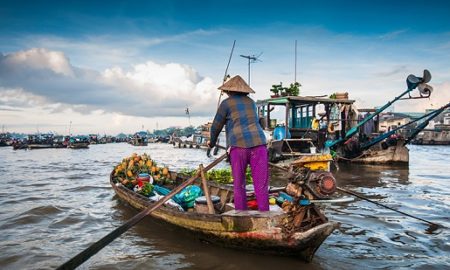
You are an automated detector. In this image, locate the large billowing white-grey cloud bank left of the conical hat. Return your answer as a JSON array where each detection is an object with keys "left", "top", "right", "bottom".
[{"left": 0, "top": 49, "right": 217, "bottom": 117}]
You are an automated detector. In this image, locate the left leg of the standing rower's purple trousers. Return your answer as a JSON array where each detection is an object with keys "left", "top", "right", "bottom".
[{"left": 230, "top": 146, "right": 250, "bottom": 210}]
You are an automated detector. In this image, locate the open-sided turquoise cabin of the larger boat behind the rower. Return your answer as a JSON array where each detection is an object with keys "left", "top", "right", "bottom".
[{"left": 256, "top": 95, "right": 357, "bottom": 161}]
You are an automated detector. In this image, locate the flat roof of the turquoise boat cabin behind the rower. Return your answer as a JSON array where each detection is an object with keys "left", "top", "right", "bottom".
[{"left": 256, "top": 96, "right": 355, "bottom": 105}]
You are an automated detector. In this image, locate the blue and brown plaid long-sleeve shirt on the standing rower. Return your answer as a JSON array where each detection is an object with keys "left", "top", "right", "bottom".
[{"left": 210, "top": 95, "right": 266, "bottom": 148}]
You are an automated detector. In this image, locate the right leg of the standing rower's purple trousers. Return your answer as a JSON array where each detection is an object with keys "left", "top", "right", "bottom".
[{"left": 249, "top": 145, "right": 269, "bottom": 211}]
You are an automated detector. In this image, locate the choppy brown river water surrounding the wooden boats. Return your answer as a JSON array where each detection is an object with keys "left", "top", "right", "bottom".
[{"left": 0, "top": 143, "right": 450, "bottom": 270}]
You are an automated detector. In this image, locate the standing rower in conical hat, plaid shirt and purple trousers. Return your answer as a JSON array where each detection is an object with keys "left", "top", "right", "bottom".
[{"left": 208, "top": 75, "right": 269, "bottom": 211}]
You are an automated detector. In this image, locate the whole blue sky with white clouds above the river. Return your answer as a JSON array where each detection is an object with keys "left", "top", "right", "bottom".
[{"left": 0, "top": 0, "right": 450, "bottom": 135}]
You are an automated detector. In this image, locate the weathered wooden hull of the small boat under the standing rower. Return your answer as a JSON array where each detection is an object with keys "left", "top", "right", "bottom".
[{"left": 110, "top": 171, "right": 338, "bottom": 262}]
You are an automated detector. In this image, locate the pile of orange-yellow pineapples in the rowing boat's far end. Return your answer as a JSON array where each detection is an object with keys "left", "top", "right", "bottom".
[{"left": 114, "top": 153, "right": 172, "bottom": 189}]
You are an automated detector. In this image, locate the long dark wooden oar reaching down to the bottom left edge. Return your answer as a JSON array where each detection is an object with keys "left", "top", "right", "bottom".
[{"left": 57, "top": 153, "right": 227, "bottom": 269}]
